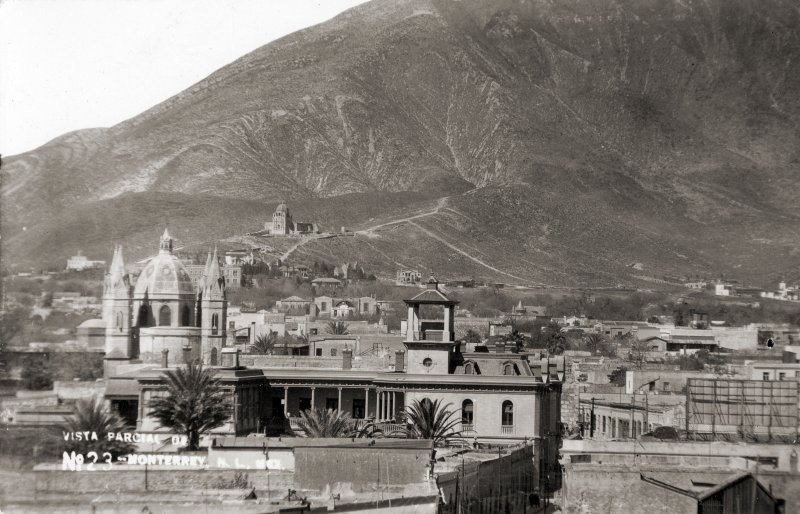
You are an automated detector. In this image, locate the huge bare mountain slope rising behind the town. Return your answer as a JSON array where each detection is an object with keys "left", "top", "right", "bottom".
[{"left": 2, "top": 0, "right": 800, "bottom": 285}]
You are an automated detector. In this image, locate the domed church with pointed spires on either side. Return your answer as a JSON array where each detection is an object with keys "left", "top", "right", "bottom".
[{"left": 103, "top": 230, "right": 228, "bottom": 376}]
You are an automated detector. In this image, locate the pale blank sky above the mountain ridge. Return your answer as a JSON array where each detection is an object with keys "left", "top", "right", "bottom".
[{"left": 0, "top": 0, "right": 364, "bottom": 156}]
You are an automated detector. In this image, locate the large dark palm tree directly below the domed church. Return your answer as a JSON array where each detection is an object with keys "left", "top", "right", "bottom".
[{"left": 151, "top": 363, "right": 230, "bottom": 451}]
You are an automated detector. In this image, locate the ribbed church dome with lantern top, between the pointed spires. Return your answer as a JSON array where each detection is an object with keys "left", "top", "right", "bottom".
[{"left": 133, "top": 231, "right": 195, "bottom": 298}]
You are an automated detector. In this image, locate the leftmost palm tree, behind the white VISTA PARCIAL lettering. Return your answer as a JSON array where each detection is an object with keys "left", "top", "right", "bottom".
[{"left": 59, "top": 398, "right": 135, "bottom": 460}]
